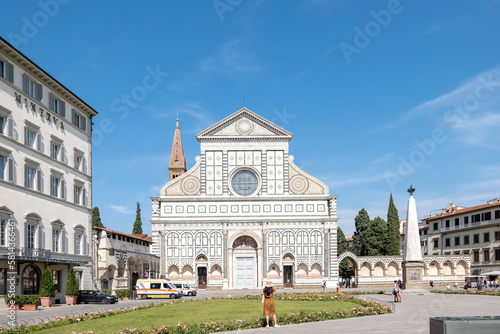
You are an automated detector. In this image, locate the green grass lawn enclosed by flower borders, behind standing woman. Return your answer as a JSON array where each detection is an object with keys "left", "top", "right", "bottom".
[{"left": 37, "top": 299, "right": 360, "bottom": 334}]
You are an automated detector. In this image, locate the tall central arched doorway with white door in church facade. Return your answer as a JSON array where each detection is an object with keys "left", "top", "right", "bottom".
[{"left": 232, "top": 235, "right": 257, "bottom": 289}]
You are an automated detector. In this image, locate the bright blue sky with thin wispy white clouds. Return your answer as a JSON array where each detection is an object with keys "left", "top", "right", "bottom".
[{"left": 0, "top": 0, "right": 500, "bottom": 237}]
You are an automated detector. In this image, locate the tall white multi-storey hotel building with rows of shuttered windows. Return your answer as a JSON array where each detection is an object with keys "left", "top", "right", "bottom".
[{"left": 0, "top": 38, "right": 97, "bottom": 302}]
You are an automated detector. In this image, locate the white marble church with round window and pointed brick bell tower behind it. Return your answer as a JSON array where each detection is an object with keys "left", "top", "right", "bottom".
[{"left": 151, "top": 108, "right": 338, "bottom": 289}]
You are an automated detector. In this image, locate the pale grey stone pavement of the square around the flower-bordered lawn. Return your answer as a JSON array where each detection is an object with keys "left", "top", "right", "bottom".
[{"left": 0, "top": 288, "right": 500, "bottom": 334}]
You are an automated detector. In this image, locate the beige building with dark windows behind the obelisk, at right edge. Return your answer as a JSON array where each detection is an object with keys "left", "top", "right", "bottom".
[{"left": 422, "top": 199, "right": 500, "bottom": 275}]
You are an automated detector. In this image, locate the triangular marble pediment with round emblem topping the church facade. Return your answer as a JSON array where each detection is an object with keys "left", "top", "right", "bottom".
[{"left": 196, "top": 108, "right": 293, "bottom": 141}]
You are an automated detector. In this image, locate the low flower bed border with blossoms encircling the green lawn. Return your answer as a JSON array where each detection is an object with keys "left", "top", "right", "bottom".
[{"left": 0, "top": 293, "right": 391, "bottom": 334}]
